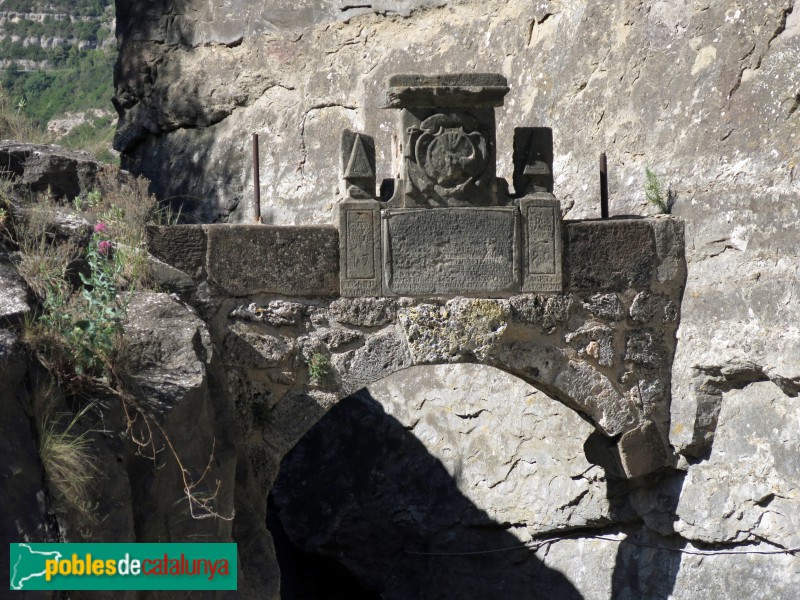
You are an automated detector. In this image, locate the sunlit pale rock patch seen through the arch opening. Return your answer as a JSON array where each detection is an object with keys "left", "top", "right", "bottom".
[{"left": 368, "top": 365, "right": 609, "bottom": 540}]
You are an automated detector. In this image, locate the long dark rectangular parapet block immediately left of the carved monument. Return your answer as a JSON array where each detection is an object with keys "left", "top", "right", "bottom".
[{"left": 207, "top": 225, "right": 339, "bottom": 296}]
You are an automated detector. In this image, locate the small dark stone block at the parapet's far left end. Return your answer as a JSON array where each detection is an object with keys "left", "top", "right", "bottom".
[{"left": 147, "top": 225, "right": 207, "bottom": 279}]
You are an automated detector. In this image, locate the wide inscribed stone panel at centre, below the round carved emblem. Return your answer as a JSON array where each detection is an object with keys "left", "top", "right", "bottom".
[{"left": 382, "top": 208, "right": 519, "bottom": 296}]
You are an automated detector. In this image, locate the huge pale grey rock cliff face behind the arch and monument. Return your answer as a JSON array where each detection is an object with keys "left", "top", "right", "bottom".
[{"left": 116, "top": 0, "right": 800, "bottom": 598}]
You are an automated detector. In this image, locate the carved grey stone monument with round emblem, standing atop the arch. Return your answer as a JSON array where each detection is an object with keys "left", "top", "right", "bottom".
[{"left": 339, "top": 73, "right": 562, "bottom": 296}]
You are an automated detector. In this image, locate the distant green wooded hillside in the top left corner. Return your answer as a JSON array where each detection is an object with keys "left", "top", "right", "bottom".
[{"left": 0, "top": 0, "right": 118, "bottom": 162}]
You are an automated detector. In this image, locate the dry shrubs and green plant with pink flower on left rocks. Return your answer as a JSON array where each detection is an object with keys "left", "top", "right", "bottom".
[{"left": 14, "top": 167, "right": 160, "bottom": 386}]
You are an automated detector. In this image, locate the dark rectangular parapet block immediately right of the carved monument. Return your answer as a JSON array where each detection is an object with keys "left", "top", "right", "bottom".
[{"left": 564, "top": 219, "right": 656, "bottom": 292}]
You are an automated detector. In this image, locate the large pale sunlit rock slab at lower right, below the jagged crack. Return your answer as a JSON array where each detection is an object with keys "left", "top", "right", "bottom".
[{"left": 675, "top": 382, "right": 800, "bottom": 548}]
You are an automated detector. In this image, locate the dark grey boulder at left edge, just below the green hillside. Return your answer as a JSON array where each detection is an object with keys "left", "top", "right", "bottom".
[{"left": 0, "top": 140, "right": 101, "bottom": 200}]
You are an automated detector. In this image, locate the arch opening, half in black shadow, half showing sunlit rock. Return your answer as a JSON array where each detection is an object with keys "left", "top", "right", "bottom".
[{"left": 270, "top": 364, "right": 596, "bottom": 600}]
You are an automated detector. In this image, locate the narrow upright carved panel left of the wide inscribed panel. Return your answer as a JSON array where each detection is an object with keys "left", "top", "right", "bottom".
[{"left": 339, "top": 200, "right": 381, "bottom": 297}]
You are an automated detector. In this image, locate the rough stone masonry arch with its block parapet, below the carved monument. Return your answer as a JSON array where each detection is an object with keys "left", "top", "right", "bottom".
[{"left": 149, "top": 217, "right": 686, "bottom": 479}]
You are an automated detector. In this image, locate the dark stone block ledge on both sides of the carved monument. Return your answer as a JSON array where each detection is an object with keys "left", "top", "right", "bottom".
[{"left": 147, "top": 217, "right": 685, "bottom": 297}]
